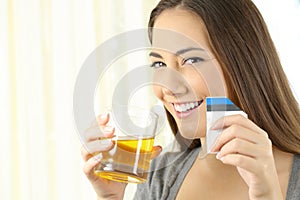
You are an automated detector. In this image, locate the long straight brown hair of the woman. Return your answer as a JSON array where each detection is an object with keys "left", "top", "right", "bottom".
[{"left": 148, "top": 0, "right": 300, "bottom": 154}]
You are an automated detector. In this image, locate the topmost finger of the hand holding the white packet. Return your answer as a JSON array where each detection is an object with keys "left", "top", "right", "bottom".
[{"left": 211, "top": 115, "right": 268, "bottom": 136}]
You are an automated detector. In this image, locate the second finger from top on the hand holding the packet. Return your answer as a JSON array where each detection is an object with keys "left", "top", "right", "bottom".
[{"left": 212, "top": 124, "right": 266, "bottom": 152}]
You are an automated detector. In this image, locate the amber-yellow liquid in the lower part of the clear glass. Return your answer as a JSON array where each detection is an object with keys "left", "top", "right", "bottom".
[{"left": 95, "top": 136, "right": 154, "bottom": 183}]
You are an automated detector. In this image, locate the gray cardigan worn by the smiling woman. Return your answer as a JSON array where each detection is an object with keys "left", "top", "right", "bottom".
[{"left": 134, "top": 148, "right": 300, "bottom": 200}]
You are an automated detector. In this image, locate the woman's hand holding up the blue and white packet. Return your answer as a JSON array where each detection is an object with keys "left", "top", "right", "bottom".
[{"left": 211, "top": 115, "right": 283, "bottom": 200}]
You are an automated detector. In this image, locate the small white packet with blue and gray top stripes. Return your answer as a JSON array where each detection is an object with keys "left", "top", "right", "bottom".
[{"left": 206, "top": 97, "right": 248, "bottom": 154}]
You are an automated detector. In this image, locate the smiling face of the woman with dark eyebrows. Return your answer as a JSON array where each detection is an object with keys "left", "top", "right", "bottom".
[{"left": 150, "top": 9, "right": 226, "bottom": 139}]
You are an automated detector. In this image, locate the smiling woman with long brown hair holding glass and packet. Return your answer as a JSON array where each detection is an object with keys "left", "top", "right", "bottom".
[{"left": 82, "top": 0, "right": 300, "bottom": 200}]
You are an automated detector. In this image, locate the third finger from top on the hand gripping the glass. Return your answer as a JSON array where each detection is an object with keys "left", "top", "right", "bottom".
[{"left": 84, "top": 140, "right": 114, "bottom": 154}]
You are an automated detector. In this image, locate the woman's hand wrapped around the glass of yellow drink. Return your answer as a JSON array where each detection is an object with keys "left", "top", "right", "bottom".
[{"left": 81, "top": 114, "right": 161, "bottom": 199}]
